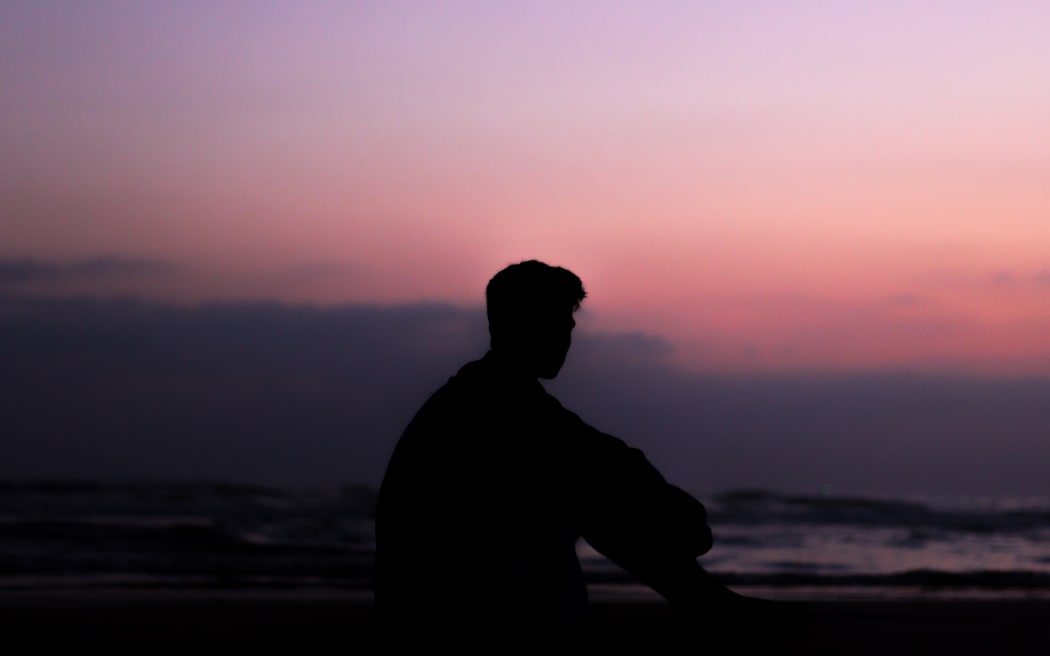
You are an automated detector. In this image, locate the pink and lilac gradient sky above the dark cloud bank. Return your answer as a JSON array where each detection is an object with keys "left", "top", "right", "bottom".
[{"left": 0, "top": 0, "right": 1050, "bottom": 376}]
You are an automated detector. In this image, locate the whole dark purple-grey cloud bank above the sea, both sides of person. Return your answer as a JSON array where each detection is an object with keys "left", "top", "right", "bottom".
[{"left": 0, "top": 297, "right": 1050, "bottom": 494}]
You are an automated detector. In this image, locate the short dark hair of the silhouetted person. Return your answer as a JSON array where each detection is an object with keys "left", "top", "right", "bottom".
[{"left": 485, "top": 259, "right": 587, "bottom": 334}]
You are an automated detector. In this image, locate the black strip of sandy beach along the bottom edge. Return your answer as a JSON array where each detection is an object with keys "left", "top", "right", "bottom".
[{"left": 0, "top": 600, "right": 1050, "bottom": 656}]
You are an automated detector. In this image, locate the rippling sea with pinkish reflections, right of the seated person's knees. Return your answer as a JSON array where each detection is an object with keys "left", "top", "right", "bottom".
[{"left": 581, "top": 490, "right": 1050, "bottom": 598}]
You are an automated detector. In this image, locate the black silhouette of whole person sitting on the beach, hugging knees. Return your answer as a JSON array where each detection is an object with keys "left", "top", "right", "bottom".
[{"left": 376, "top": 260, "right": 789, "bottom": 635}]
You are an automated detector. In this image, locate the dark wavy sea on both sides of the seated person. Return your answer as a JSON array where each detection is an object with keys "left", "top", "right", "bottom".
[{"left": 0, "top": 481, "right": 1050, "bottom": 607}]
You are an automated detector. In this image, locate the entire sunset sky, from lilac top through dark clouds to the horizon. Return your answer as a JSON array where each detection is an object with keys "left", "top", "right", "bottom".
[{"left": 0, "top": 0, "right": 1050, "bottom": 493}]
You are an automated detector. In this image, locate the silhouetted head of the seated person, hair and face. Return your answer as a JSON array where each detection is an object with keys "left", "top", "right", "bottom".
[{"left": 485, "top": 259, "right": 587, "bottom": 378}]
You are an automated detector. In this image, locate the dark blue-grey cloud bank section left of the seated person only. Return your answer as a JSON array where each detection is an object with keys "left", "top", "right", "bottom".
[{"left": 0, "top": 297, "right": 483, "bottom": 482}]
